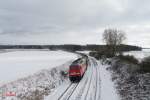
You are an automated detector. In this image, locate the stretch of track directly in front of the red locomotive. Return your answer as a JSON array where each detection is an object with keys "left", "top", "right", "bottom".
[{"left": 58, "top": 83, "right": 79, "bottom": 100}]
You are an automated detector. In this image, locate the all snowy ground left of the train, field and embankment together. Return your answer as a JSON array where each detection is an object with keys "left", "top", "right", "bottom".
[{"left": 0, "top": 50, "right": 77, "bottom": 100}]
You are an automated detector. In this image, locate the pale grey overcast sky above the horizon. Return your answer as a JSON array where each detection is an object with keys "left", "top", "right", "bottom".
[{"left": 0, "top": 0, "right": 150, "bottom": 47}]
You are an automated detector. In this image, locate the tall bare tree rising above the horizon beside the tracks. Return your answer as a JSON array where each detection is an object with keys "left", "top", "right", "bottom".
[{"left": 103, "top": 29, "right": 126, "bottom": 56}]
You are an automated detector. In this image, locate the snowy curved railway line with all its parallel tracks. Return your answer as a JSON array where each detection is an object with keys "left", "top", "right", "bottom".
[{"left": 46, "top": 57, "right": 100, "bottom": 100}]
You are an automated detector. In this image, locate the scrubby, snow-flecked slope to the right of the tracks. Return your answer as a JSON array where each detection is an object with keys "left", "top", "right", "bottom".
[{"left": 109, "top": 59, "right": 150, "bottom": 100}]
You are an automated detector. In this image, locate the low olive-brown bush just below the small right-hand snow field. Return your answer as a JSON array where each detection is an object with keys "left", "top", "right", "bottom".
[{"left": 118, "top": 55, "right": 139, "bottom": 64}]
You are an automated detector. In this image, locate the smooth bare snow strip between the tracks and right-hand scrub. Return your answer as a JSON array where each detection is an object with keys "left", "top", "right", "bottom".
[{"left": 99, "top": 61, "right": 120, "bottom": 100}]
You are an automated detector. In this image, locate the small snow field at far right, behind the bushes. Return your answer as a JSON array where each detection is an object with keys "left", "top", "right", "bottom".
[{"left": 124, "top": 49, "right": 150, "bottom": 61}]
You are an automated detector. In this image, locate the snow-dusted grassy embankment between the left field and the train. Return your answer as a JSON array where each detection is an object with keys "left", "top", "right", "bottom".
[{"left": 0, "top": 61, "right": 72, "bottom": 100}]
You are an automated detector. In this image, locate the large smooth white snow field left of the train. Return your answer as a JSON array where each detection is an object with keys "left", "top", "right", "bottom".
[{"left": 0, "top": 50, "right": 77, "bottom": 85}]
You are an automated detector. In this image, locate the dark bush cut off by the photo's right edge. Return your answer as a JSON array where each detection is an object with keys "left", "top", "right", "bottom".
[{"left": 140, "top": 56, "right": 150, "bottom": 72}]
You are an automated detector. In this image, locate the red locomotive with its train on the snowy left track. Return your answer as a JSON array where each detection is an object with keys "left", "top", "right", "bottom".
[{"left": 69, "top": 58, "right": 87, "bottom": 82}]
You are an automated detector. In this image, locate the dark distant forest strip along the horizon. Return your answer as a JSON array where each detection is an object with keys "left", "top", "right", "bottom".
[{"left": 0, "top": 44, "right": 142, "bottom": 51}]
